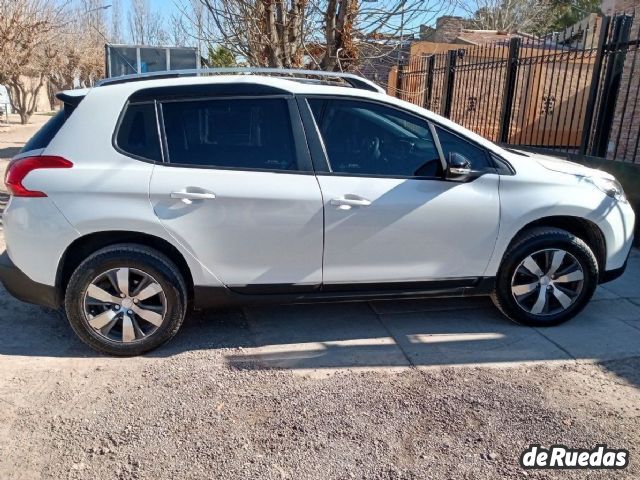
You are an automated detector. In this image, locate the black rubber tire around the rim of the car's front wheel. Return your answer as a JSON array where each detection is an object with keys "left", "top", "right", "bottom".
[{"left": 491, "top": 227, "right": 599, "bottom": 327}]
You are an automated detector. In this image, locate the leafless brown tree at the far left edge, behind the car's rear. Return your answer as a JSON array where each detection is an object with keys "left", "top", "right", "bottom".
[{"left": 0, "top": 0, "right": 63, "bottom": 124}]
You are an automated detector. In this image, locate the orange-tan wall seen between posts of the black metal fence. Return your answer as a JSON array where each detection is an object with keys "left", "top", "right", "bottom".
[{"left": 396, "top": 44, "right": 595, "bottom": 149}]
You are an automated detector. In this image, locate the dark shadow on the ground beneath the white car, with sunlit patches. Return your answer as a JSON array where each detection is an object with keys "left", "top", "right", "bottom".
[{"left": 0, "top": 282, "right": 640, "bottom": 385}]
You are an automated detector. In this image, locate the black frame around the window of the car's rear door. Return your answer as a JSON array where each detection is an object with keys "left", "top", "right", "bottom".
[{"left": 157, "top": 94, "right": 315, "bottom": 175}]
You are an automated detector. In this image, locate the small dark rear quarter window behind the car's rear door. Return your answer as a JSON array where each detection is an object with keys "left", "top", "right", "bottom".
[{"left": 116, "top": 103, "right": 162, "bottom": 161}]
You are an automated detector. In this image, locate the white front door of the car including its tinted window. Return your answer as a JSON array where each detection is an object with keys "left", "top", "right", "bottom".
[{"left": 308, "top": 97, "right": 500, "bottom": 289}]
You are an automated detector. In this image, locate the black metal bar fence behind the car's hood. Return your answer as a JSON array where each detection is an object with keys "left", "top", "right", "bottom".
[{"left": 395, "top": 14, "right": 640, "bottom": 163}]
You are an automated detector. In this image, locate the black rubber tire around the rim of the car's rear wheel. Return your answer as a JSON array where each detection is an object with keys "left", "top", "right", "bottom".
[{"left": 64, "top": 244, "right": 187, "bottom": 356}]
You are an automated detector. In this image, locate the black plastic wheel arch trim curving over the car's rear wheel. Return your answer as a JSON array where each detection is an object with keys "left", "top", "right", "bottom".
[{"left": 56, "top": 230, "right": 194, "bottom": 302}]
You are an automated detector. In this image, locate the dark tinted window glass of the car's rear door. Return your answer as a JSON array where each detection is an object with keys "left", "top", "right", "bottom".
[{"left": 162, "top": 98, "right": 297, "bottom": 170}]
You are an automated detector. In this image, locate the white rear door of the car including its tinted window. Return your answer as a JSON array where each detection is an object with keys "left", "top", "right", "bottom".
[{"left": 150, "top": 95, "right": 323, "bottom": 293}]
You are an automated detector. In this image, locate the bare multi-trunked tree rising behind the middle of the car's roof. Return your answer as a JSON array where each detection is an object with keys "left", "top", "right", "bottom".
[{"left": 182, "top": 0, "right": 448, "bottom": 70}]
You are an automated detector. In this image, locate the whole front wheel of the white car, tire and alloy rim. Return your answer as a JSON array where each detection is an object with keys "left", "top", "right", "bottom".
[{"left": 492, "top": 228, "right": 598, "bottom": 326}]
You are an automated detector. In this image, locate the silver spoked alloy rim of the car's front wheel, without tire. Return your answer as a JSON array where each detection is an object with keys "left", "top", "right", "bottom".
[{"left": 511, "top": 248, "right": 584, "bottom": 316}]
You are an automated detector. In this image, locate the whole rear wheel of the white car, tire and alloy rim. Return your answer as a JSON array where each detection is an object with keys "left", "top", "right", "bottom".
[{"left": 65, "top": 244, "right": 186, "bottom": 355}]
